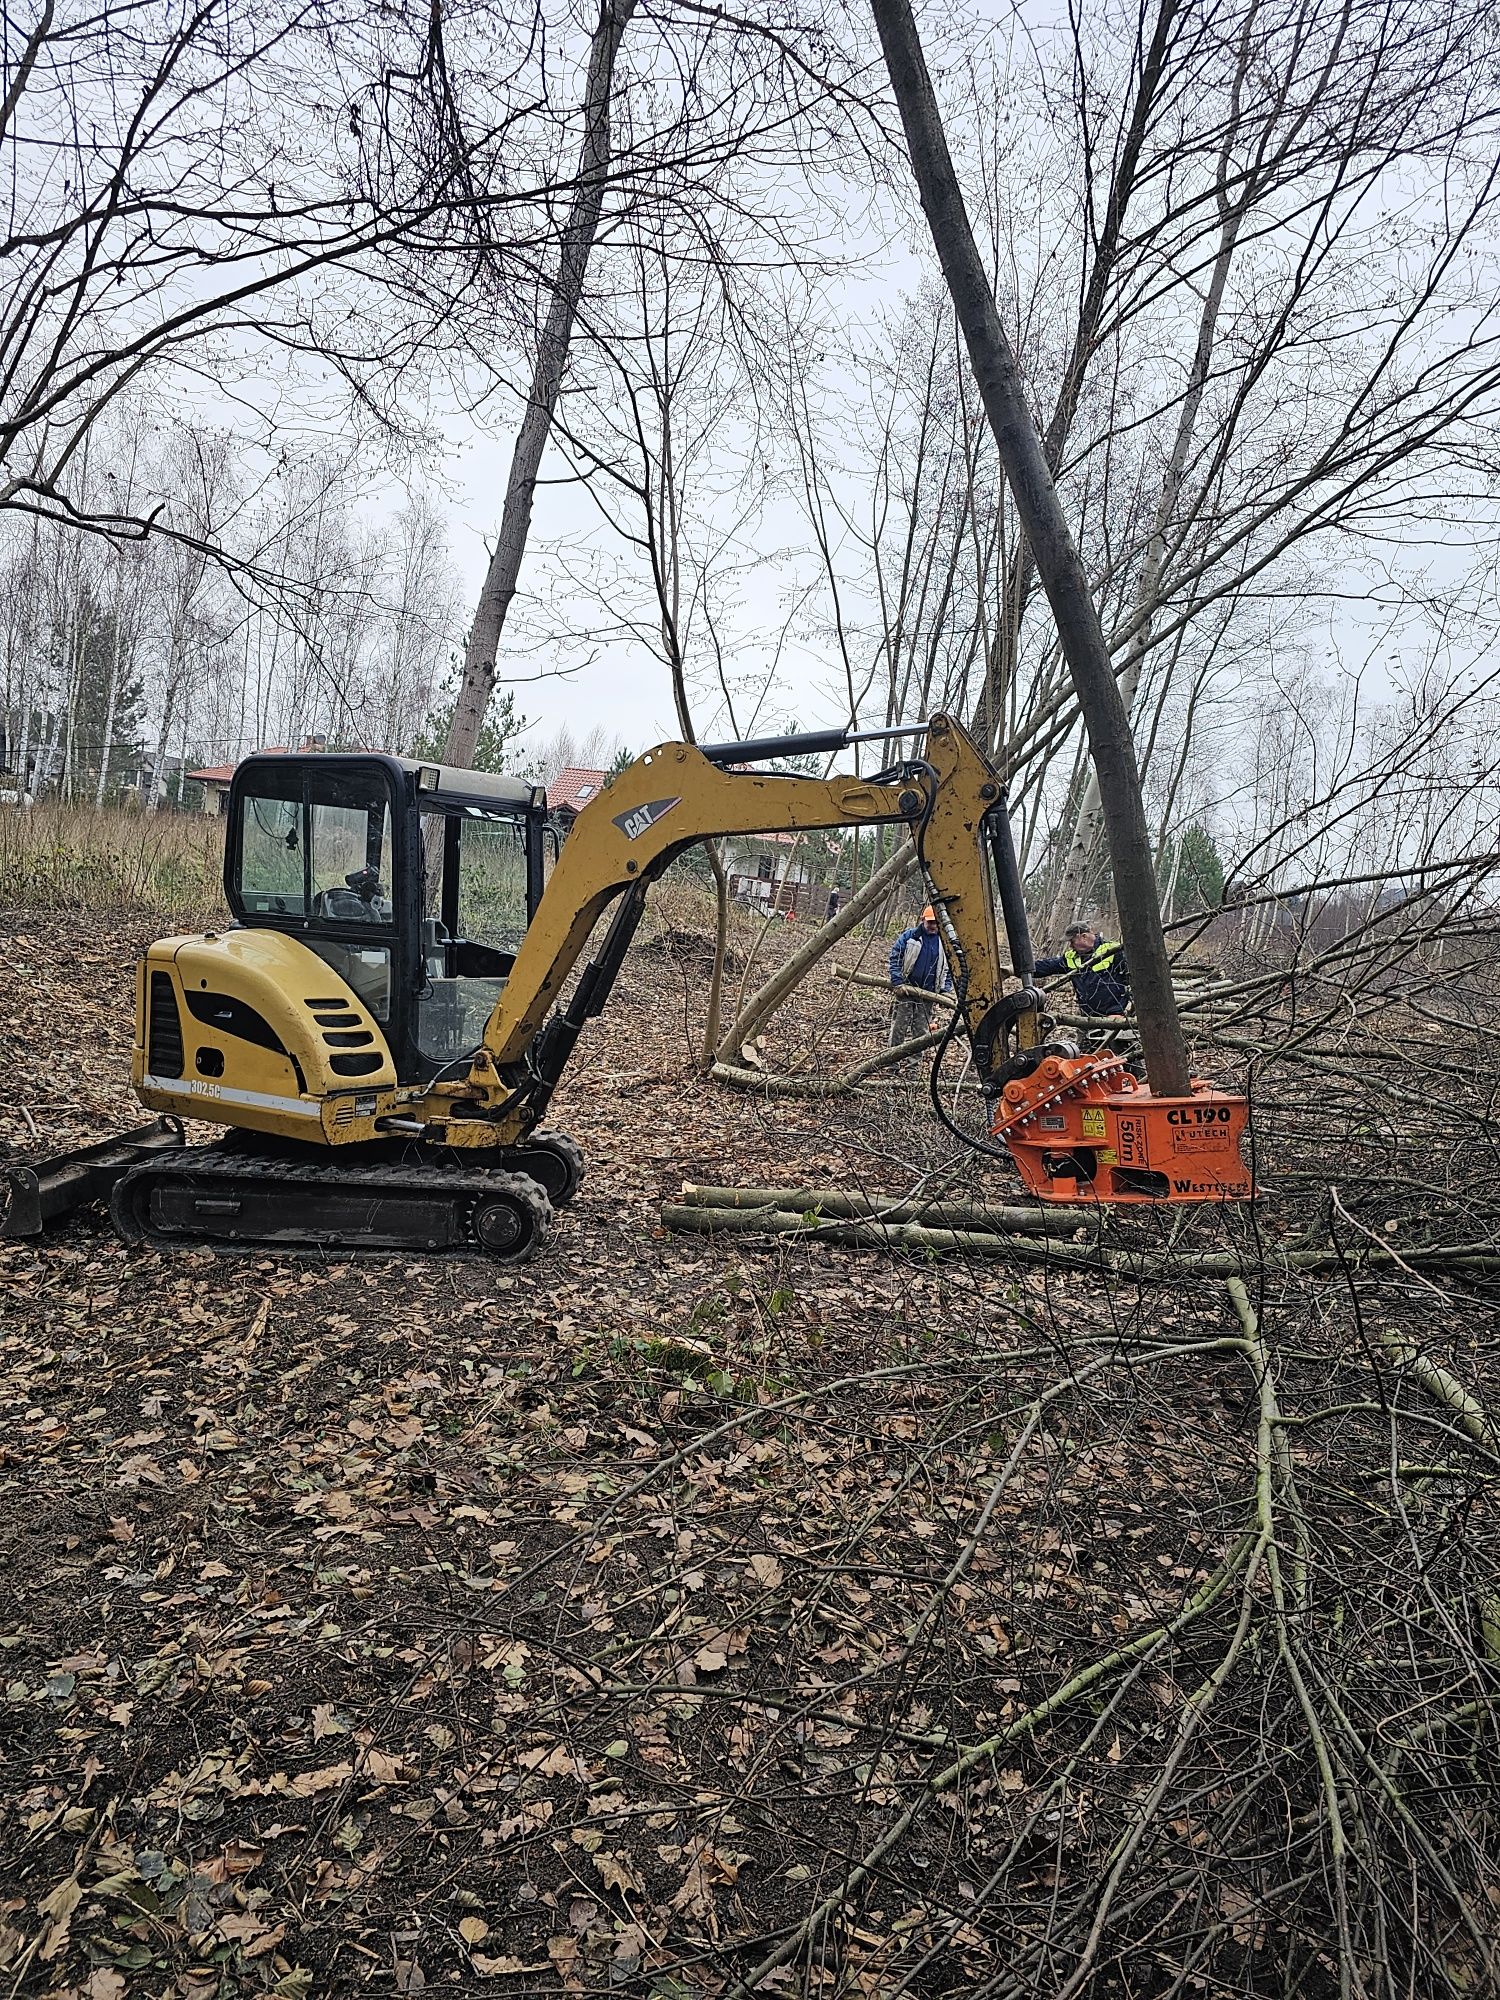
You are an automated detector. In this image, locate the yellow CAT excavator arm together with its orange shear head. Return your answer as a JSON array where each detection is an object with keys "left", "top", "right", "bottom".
[{"left": 440, "top": 716, "right": 1254, "bottom": 1204}]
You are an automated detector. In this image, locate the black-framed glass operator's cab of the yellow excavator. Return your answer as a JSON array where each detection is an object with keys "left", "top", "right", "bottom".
[{"left": 224, "top": 756, "right": 546, "bottom": 1084}]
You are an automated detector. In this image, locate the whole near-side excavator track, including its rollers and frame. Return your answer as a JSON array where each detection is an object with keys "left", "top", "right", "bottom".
[{"left": 110, "top": 1146, "right": 552, "bottom": 1264}]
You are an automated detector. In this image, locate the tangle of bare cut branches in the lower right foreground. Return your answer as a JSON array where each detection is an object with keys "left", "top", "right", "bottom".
[{"left": 734, "top": 1280, "right": 1500, "bottom": 2000}]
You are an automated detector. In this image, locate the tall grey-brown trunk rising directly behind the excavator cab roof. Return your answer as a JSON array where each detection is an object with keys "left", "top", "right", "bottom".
[{"left": 444, "top": 0, "right": 636, "bottom": 764}]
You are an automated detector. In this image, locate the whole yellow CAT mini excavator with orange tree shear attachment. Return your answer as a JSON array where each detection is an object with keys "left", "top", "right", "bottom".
[{"left": 0, "top": 716, "right": 1250, "bottom": 1260}]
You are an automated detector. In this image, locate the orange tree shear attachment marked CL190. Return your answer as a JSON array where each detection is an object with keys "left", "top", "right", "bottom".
[{"left": 994, "top": 1054, "right": 1256, "bottom": 1202}]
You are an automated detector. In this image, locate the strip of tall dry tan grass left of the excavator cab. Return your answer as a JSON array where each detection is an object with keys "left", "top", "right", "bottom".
[{"left": 0, "top": 800, "right": 224, "bottom": 924}]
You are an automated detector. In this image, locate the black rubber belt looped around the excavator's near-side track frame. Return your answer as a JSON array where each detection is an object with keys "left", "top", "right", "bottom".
[{"left": 110, "top": 1146, "right": 554, "bottom": 1264}]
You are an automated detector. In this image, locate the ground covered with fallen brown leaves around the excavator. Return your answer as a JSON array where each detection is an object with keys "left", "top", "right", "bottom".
[{"left": 0, "top": 914, "right": 1500, "bottom": 2000}]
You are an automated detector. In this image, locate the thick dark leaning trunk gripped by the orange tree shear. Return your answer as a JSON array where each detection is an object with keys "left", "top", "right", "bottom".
[{"left": 872, "top": 0, "right": 1188, "bottom": 1096}]
